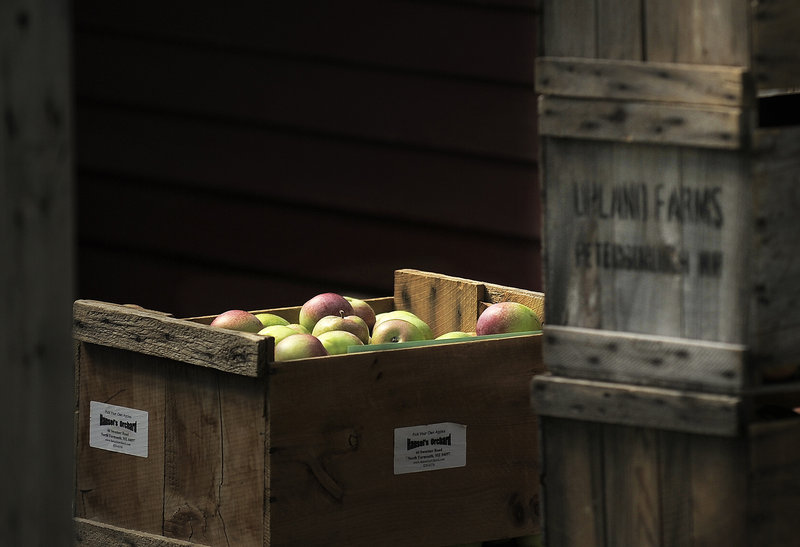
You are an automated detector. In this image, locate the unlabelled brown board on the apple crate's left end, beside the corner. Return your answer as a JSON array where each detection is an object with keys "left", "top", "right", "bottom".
[{"left": 164, "top": 366, "right": 266, "bottom": 545}]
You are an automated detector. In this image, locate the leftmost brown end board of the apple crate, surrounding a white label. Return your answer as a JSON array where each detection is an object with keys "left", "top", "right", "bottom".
[{"left": 75, "top": 343, "right": 167, "bottom": 534}]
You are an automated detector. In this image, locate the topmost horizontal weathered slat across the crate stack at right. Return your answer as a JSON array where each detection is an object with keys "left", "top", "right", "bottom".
[{"left": 536, "top": 57, "right": 754, "bottom": 106}]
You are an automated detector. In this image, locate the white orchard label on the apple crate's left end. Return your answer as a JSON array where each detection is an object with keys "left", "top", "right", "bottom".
[{"left": 89, "top": 401, "right": 148, "bottom": 458}]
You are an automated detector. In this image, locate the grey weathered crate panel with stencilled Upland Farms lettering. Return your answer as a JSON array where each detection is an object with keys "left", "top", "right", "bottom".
[{"left": 543, "top": 139, "right": 751, "bottom": 343}]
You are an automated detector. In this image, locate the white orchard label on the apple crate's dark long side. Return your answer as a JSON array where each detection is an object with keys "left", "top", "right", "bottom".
[{"left": 394, "top": 422, "right": 467, "bottom": 475}]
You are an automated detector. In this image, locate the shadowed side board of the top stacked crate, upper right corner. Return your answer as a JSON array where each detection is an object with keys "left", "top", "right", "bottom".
[{"left": 752, "top": 0, "right": 800, "bottom": 89}]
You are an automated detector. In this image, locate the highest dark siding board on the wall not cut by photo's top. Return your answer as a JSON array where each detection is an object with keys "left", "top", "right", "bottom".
[{"left": 75, "top": 35, "right": 536, "bottom": 161}]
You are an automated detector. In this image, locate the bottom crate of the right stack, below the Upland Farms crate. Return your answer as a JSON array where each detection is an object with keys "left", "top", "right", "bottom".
[{"left": 533, "top": 375, "right": 800, "bottom": 547}]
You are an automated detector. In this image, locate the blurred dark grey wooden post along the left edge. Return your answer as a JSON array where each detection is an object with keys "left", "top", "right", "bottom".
[{"left": 0, "top": 0, "right": 74, "bottom": 546}]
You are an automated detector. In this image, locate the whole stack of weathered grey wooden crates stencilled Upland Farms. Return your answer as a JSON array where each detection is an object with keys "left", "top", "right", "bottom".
[{"left": 532, "top": 0, "right": 800, "bottom": 547}]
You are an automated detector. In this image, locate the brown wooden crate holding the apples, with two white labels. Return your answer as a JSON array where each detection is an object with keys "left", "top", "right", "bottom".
[{"left": 74, "top": 270, "right": 543, "bottom": 546}]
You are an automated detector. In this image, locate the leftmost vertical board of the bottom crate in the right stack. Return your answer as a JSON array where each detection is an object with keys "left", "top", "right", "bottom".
[{"left": 540, "top": 416, "right": 606, "bottom": 547}]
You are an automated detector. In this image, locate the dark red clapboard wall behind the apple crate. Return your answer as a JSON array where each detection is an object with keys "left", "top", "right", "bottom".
[{"left": 74, "top": 0, "right": 542, "bottom": 316}]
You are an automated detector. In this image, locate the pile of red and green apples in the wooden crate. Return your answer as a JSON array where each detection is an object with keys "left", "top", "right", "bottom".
[{"left": 211, "top": 292, "right": 542, "bottom": 361}]
